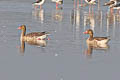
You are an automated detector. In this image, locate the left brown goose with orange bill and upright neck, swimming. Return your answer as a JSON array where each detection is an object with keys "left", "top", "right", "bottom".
[{"left": 18, "top": 25, "right": 49, "bottom": 41}]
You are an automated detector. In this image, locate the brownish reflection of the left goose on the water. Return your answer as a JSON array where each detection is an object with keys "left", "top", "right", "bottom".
[{"left": 20, "top": 40, "right": 47, "bottom": 55}]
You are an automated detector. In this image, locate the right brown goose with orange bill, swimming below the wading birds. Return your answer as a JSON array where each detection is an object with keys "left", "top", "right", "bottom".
[{"left": 83, "top": 29, "right": 110, "bottom": 45}]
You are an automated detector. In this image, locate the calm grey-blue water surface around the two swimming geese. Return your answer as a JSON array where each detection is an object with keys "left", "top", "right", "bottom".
[{"left": 0, "top": 0, "right": 120, "bottom": 80}]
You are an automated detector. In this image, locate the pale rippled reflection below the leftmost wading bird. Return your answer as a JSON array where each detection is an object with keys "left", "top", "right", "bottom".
[{"left": 32, "top": 9, "right": 44, "bottom": 23}]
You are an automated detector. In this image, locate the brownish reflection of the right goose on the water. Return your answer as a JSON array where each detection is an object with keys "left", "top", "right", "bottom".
[{"left": 85, "top": 43, "right": 109, "bottom": 56}]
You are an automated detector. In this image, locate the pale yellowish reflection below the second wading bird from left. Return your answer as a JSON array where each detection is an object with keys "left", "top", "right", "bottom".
[{"left": 52, "top": 8, "right": 63, "bottom": 21}]
